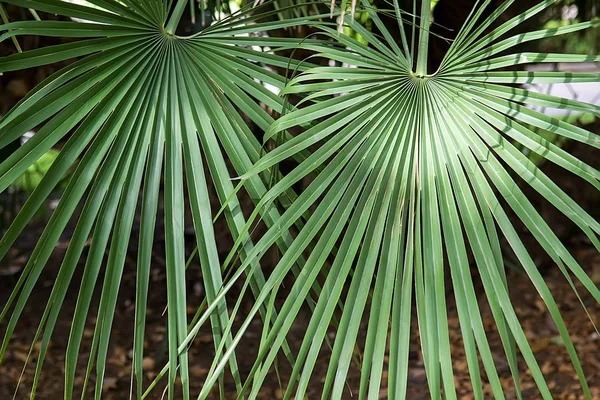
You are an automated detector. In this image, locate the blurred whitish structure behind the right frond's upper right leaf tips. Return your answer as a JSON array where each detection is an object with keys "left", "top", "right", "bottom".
[{"left": 523, "top": 63, "right": 600, "bottom": 117}]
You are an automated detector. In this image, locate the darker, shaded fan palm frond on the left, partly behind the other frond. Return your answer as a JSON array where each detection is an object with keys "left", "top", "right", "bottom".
[{"left": 0, "top": 0, "right": 328, "bottom": 398}]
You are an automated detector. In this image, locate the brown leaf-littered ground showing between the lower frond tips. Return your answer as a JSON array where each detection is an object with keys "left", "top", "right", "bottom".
[{"left": 0, "top": 214, "right": 600, "bottom": 400}]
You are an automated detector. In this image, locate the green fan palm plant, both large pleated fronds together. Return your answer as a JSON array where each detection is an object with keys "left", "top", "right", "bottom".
[{"left": 0, "top": 0, "right": 600, "bottom": 399}]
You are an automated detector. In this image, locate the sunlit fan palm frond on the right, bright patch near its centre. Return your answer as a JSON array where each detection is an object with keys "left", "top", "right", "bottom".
[{"left": 209, "top": 0, "right": 600, "bottom": 399}]
